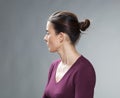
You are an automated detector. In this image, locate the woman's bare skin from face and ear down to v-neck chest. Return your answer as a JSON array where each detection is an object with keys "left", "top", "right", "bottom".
[{"left": 44, "top": 21, "right": 81, "bottom": 82}]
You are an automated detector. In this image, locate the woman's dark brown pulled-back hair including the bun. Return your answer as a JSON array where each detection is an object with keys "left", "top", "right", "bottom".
[{"left": 48, "top": 11, "right": 90, "bottom": 45}]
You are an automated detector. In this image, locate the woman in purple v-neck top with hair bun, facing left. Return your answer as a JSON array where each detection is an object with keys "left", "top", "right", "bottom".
[{"left": 43, "top": 11, "right": 96, "bottom": 98}]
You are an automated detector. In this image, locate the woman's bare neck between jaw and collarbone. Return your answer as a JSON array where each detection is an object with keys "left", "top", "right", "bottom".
[{"left": 57, "top": 44, "right": 80, "bottom": 65}]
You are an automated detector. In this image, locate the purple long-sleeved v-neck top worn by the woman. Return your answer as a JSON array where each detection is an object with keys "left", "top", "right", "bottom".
[{"left": 42, "top": 56, "right": 96, "bottom": 98}]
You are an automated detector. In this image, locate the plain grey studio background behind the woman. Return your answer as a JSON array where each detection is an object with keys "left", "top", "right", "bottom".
[{"left": 0, "top": 0, "right": 120, "bottom": 98}]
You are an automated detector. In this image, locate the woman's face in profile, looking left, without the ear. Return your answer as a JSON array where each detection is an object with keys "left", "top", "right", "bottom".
[{"left": 44, "top": 21, "right": 60, "bottom": 52}]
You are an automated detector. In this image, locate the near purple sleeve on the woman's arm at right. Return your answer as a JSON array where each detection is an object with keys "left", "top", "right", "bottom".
[{"left": 74, "top": 67, "right": 95, "bottom": 98}]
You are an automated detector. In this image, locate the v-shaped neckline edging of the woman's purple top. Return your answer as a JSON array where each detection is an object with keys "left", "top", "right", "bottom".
[{"left": 54, "top": 55, "right": 82, "bottom": 84}]
